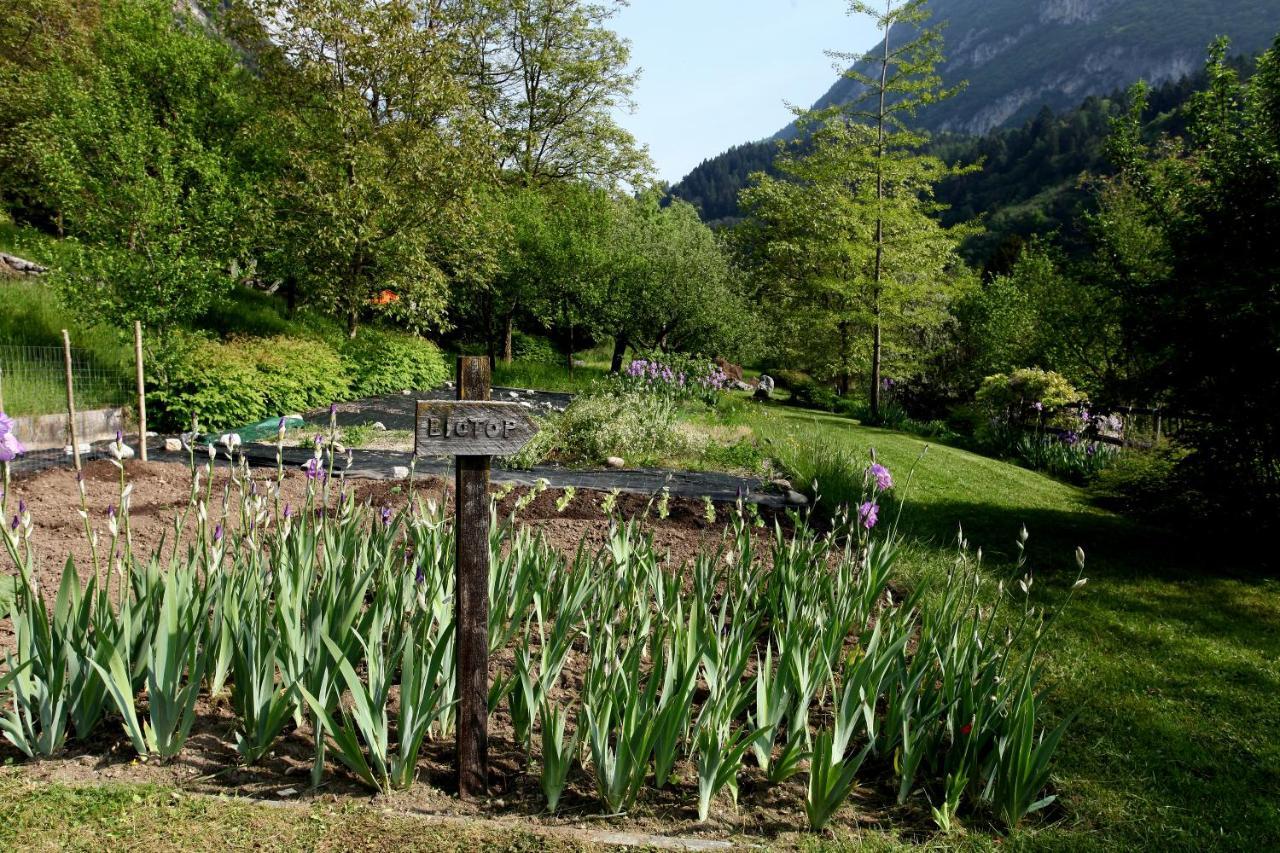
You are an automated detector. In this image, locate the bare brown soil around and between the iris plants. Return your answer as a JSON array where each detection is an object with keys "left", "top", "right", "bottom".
[{"left": 0, "top": 461, "right": 928, "bottom": 844}]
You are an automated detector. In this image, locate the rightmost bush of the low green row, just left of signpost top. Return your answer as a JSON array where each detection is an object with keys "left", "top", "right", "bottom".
[{"left": 342, "top": 328, "right": 449, "bottom": 397}]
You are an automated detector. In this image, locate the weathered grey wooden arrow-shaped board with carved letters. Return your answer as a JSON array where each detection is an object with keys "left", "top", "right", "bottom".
[{"left": 413, "top": 400, "right": 538, "bottom": 456}]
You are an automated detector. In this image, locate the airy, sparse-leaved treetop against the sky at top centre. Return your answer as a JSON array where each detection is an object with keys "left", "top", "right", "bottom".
[{"left": 467, "top": 0, "right": 652, "bottom": 186}]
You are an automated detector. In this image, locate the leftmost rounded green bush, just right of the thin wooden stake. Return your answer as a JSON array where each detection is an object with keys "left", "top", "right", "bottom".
[{"left": 146, "top": 332, "right": 266, "bottom": 432}]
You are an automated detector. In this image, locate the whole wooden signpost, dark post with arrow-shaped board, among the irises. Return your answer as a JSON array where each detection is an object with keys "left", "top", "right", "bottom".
[{"left": 413, "top": 356, "right": 538, "bottom": 797}]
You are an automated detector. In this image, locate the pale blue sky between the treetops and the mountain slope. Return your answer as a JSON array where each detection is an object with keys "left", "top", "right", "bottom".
[{"left": 612, "top": 0, "right": 876, "bottom": 183}]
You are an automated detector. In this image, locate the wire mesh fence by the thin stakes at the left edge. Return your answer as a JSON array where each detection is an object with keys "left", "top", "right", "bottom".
[{"left": 0, "top": 343, "right": 132, "bottom": 471}]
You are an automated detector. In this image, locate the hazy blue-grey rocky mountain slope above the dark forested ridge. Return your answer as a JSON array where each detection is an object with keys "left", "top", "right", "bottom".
[{"left": 798, "top": 0, "right": 1280, "bottom": 134}]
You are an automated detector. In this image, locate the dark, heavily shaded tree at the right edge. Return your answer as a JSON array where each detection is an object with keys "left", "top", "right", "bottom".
[{"left": 1094, "top": 38, "right": 1280, "bottom": 524}]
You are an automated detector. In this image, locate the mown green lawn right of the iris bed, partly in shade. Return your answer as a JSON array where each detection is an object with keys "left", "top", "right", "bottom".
[{"left": 755, "top": 409, "right": 1280, "bottom": 849}]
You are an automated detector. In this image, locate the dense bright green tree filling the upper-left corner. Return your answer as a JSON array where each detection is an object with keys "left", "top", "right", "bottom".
[{"left": 0, "top": 0, "right": 262, "bottom": 330}]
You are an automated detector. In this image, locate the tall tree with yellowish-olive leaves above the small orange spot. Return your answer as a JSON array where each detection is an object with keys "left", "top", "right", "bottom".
[{"left": 237, "top": 0, "right": 497, "bottom": 334}]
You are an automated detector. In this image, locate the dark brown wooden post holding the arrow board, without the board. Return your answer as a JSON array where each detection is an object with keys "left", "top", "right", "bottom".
[{"left": 453, "top": 356, "right": 490, "bottom": 798}]
